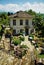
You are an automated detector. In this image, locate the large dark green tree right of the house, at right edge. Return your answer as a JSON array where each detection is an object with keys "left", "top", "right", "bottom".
[{"left": 33, "top": 14, "right": 44, "bottom": 37}]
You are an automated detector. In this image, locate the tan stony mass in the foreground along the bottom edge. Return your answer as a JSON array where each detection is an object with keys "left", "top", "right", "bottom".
[{"left": 0, "top": 50, "right": 35, "bottom": 65}]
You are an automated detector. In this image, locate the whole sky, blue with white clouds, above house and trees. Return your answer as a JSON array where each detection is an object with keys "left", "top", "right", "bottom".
[{"left": 0, "top": 0, "right": 44, "bottom": 13}]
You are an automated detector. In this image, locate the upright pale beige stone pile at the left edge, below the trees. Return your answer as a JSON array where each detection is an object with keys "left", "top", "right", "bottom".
[{"left": 0, "top": 35, "right": 10, "bottom": 50}]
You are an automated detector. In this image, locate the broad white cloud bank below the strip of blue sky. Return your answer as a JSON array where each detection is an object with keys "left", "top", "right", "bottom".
[{"left": 0, "top": 2, "right": 44, "bottom": 13}]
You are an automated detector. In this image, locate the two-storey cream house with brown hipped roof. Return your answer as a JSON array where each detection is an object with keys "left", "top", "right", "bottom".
[{"left": 10, "top": 11, "right": 33, "bottom": 35}]
